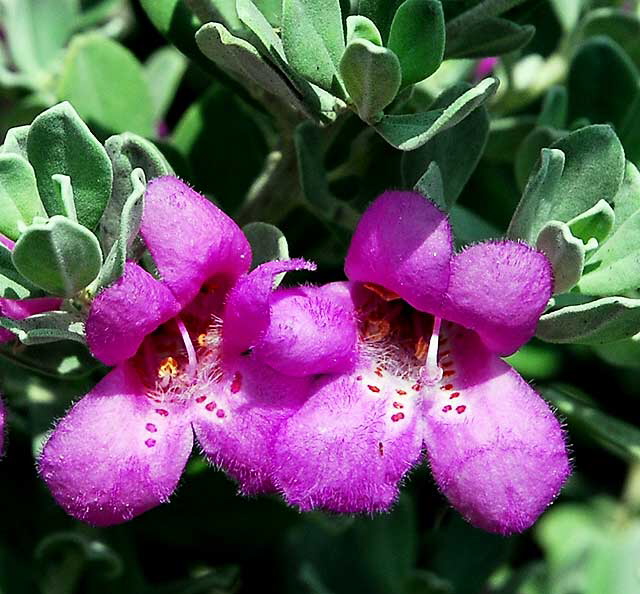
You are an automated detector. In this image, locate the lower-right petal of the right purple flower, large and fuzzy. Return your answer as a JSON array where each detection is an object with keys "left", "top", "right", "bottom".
[{"left": 425, "top": 324, "right": 570, "bottom": 534}]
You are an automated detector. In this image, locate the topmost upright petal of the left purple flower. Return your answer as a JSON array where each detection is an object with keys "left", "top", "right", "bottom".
[{"left": 140, "top": 176, "right": 251, "bottom": 306}]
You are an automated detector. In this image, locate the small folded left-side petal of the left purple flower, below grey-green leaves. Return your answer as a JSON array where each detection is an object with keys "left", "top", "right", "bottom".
[{"left": 86, "top": 262, "right": 180, "bottom": 365}]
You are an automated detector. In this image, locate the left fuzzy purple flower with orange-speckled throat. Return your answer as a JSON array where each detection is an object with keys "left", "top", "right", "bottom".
[{"left": 39, "top": 177, "right": 356, "bottom": 525}]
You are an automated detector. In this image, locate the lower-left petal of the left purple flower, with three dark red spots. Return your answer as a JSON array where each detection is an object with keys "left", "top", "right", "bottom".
[{"left": 39, "top": 364, "right": 193, "bottom": 526}]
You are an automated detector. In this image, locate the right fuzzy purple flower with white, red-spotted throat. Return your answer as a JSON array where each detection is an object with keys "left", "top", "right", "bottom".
[{"left": 272, "top": 192, "right": 570, "bottom": 534}]
